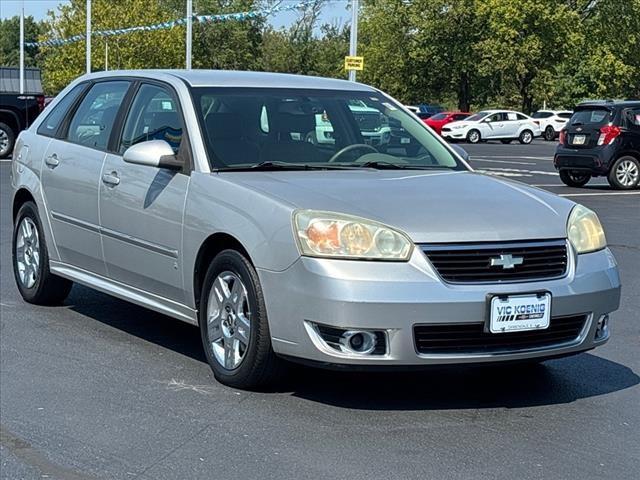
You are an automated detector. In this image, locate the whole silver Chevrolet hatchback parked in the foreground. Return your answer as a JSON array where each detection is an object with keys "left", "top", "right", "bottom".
[{"left": 12, "top": 71, "right": 620, "bottom": 388}]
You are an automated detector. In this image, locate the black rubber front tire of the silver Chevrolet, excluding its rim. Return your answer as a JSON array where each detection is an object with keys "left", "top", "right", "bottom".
[{"left": 198, "top": 250, "right": 273, "bottom": 388}]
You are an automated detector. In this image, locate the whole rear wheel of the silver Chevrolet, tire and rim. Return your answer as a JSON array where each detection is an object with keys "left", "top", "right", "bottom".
[{"left": 12, "top": 202, "right": 73, "bottom": 305}]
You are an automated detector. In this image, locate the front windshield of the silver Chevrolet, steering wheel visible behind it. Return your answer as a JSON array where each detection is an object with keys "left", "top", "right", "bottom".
[{"left": 192, "top": 87, "right": 467, "bottom": 171}]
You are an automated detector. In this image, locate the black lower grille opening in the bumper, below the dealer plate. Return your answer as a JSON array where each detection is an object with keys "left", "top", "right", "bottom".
[{"left": 413, "top": 315, "right": 587, "bottom": 355}]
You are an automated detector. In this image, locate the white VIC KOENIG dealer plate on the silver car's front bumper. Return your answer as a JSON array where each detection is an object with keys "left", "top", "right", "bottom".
[{"left": 489, "top": 292, "right": 551, "bottom": 333}]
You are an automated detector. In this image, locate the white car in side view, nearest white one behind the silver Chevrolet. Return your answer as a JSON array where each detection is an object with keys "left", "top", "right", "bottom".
[{"left": 442, "top": 110, "right": 542, "bottom": 144}]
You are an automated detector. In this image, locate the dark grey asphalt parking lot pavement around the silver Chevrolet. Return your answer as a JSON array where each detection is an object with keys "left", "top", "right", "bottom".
[{"left": 0, "top": 140, "right": 640, "bottom": 480}]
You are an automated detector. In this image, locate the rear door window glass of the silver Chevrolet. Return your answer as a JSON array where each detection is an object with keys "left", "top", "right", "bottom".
[{"left": 67, "top": 81, "right": 129, "bottom": 150}]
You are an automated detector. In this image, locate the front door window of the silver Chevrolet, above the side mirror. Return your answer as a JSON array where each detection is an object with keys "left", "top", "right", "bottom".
[{"left": 119, "top": 85, "right": 182, "bottom": 153}]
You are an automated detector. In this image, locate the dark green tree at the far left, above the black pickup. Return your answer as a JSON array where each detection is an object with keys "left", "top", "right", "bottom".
[{"left": 0, "top": 16, "right": 43, "bottom": 67}]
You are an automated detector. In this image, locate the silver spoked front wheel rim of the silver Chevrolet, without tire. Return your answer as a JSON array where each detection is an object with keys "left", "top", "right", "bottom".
[{"left": 207, "top": 271, "right": 251, "bottom": 370}]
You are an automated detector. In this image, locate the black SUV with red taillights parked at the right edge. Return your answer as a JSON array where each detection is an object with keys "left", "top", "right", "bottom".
[{"left": 553, "top": 100, "right": 640, "bottom": 190}]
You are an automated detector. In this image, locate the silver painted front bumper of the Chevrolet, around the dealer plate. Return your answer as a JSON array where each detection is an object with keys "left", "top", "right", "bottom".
[{"left": 258, "top": 249, "right": 620, "bottom": 366}]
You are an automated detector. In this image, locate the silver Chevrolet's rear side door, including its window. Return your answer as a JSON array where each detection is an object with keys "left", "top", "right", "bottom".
[{"left": 41, "top": 80, "right": 130, "bottom": 274}]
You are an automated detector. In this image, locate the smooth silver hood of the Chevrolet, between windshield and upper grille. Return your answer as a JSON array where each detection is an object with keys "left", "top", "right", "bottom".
[{"left": 225, "top": 169, "right": 574, "bottom": 243}]
